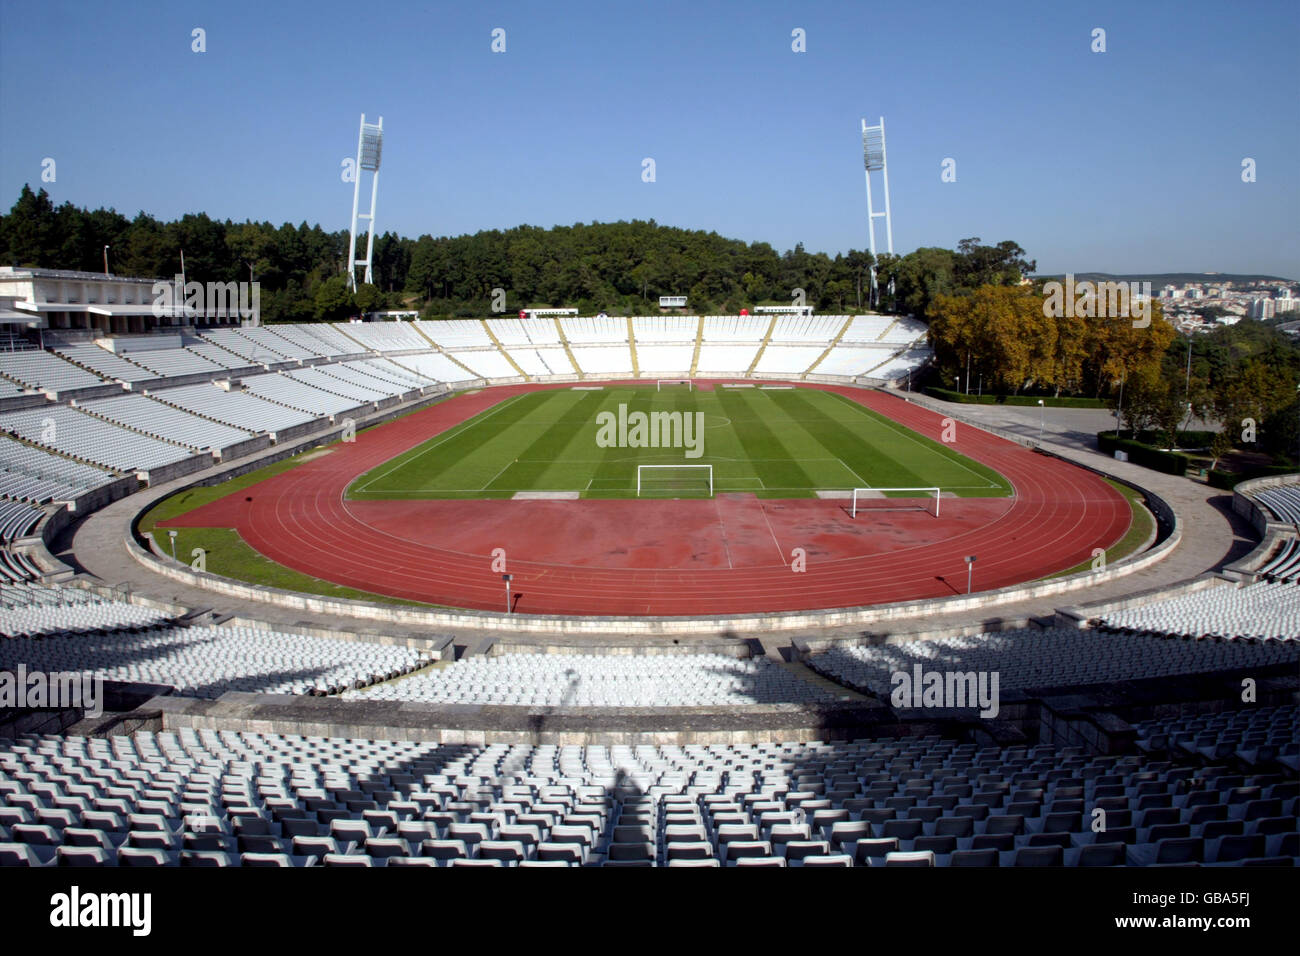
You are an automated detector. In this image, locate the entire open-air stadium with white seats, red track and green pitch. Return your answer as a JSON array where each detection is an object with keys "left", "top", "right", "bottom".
[{"left": 0, "top": 299, "right": 1300, "bottom": 866}]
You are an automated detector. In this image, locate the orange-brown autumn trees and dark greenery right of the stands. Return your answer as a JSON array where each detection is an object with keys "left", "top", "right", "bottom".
[{"left": 928, "top": 284, "right": 1300, "bottom": 460}]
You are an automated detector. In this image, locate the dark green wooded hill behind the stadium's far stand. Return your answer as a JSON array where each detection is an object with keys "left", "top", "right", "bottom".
[{"left": 0, "top": 186, "right": 1034, "bottom": 323}]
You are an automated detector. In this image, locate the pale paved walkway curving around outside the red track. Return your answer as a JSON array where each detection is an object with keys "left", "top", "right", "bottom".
[{"left": 56, "top": 392, "right": 1257, "bottom": 646}]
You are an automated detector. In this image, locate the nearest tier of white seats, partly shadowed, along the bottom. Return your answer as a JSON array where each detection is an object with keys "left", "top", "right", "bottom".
[{"left": 0, "top": 723, "right": 1300, "bottom": 868}]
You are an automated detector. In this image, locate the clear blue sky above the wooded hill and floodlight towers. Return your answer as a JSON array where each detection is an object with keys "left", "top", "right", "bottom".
[{"left": 0, "top": 0, "right": 1300, "bottom": 277}]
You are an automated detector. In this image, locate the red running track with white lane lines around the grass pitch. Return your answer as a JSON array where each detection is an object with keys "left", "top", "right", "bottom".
[{"left": 164, "top": 382, "right": 1130, "bottom": 617}]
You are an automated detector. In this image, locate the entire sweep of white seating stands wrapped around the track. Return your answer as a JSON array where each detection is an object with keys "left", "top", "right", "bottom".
[{"left": 0, "top": 315, "right": 1300, "bottom": 868}]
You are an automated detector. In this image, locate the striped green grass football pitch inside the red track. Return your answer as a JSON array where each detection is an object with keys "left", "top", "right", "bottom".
[{"left": 348, "top": 385, "right": 1011, "bottom": 499}]
